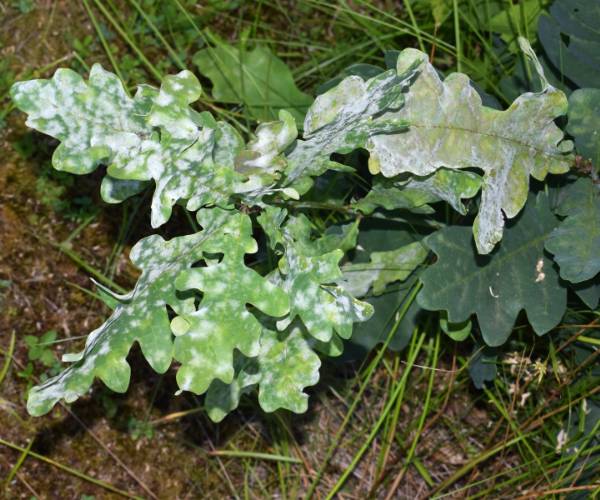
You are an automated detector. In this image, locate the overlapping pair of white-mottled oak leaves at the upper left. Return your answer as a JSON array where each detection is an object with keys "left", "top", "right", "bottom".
[{"left": 12, "top": 65, "right": 243, "bottom": 227}]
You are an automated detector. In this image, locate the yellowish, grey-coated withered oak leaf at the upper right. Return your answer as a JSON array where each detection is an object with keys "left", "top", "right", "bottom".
[{"left": 367, "top": 40, "right": 571, "bottom": 253}]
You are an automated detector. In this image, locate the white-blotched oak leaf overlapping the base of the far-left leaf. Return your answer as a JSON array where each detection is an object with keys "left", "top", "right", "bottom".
[{"left": 108, "top": 71, "right": 243, "bottom": 227}]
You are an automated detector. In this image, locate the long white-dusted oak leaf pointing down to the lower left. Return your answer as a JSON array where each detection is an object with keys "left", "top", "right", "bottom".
[{"left": 28, "top": 213, "right": 225, "bottom": 415}]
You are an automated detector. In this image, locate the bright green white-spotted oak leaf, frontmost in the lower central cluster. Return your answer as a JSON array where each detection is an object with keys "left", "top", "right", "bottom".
[{"left": 172, "top": 213, "right": 289, "bottom": 394}]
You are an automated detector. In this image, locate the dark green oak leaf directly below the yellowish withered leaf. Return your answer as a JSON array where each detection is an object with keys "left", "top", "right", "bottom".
[{"left": 417, "top": 195, "right": 566, "bottom": 346}]
